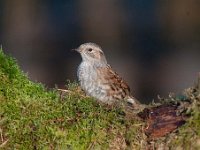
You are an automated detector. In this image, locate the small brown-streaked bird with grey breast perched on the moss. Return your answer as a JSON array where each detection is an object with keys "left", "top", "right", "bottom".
[{"left": 74, "top": 42, "right": 139, "bottom": 107}]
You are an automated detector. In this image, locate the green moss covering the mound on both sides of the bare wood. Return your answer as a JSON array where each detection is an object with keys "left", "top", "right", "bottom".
[{"left": 0, "top": 50, "right": 200, "bottom": 149}]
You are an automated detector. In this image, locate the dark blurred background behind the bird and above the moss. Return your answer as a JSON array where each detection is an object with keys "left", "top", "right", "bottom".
[{"left": 0, "top": 0, "right": 200, "bottom": 102}]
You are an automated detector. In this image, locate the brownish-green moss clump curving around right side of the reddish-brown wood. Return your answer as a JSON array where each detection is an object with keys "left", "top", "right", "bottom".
[{"left": 145, "top": 86, "right": 200, "bottom": 150}]
